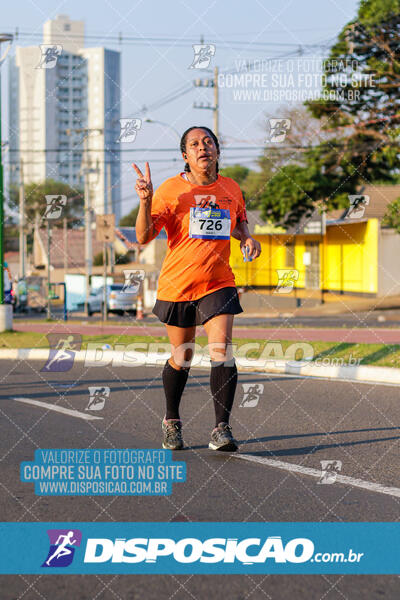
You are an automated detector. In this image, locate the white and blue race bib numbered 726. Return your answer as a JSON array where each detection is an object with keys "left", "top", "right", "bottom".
[{"left": 189, "top": 207, "right": 231, "bottom": 240}]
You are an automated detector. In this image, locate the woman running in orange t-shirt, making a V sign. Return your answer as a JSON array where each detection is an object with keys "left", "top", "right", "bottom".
[{"left": 132, "top": 127, "right": 261, "bottom": 452}]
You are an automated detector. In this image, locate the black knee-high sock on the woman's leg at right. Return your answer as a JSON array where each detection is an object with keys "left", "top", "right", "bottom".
[{"left": 210, "top": 359, "right": 237, "bottom": 427}]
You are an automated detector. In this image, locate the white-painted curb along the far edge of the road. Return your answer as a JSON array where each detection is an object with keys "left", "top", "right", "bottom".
[{"left": 0, "top": 348, "right": 400, "bottom": 385}]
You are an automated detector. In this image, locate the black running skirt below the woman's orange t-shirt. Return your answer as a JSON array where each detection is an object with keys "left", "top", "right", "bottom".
[{"left": 153, "top": 287, "right": 243, "bottom": 327}]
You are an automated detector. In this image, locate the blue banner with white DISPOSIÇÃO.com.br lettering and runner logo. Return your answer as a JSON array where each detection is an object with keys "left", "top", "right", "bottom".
[{"left": 0, "top": 522, "right": 400, "bottom": 575}]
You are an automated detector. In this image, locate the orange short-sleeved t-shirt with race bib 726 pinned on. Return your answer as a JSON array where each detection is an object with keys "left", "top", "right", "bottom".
[{"left": 149, "top": 175, "right": 247, "bottom": 302}]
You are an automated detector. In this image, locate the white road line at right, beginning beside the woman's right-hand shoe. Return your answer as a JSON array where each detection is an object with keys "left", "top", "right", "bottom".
[{"left": 235, "top": 454, "right": 400, "bottom": 498}]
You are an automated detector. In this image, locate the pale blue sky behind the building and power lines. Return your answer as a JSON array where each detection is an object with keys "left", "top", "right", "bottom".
[{"left": 2, "top": 0, "right": 358, "bottom": 213}]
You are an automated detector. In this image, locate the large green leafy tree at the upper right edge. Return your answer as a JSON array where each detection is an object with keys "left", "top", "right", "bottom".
[{"left": 261, "top": 0, "right": 400, "bottom": 224}]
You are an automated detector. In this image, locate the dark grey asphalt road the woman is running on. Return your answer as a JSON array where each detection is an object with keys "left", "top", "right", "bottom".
[{"left": 0, "top": 361, "right": 400, "bottom": 600}]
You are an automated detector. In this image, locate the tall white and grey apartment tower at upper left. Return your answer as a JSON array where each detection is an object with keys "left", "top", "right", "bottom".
[{"left": 9, "top": 15, "right": 121, "bottom": 223}]
